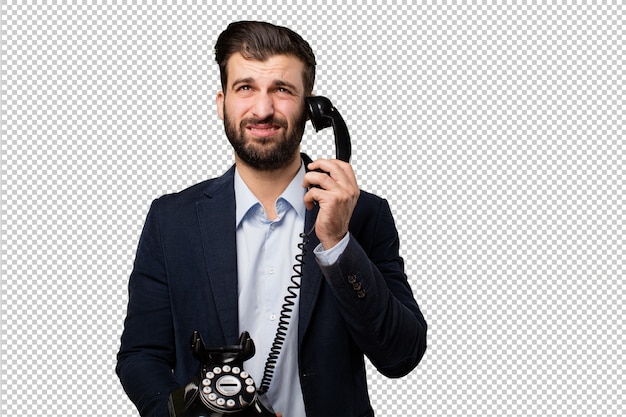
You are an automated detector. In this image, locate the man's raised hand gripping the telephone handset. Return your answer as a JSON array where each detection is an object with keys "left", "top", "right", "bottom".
[{"left": 302, "top": 159, "right": 360, "bottom": 250}]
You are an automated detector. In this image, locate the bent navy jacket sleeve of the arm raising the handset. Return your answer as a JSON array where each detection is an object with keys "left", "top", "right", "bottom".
[{"left": 320, "top": 199, "right": 427, "bottom": 377}]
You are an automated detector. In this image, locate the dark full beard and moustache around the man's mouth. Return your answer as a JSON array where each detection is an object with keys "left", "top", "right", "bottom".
[{"left": 224, "top": 109, "right": 306, "bottom": 171}]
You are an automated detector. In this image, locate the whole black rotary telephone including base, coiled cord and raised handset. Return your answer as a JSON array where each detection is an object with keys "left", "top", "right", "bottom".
[{"left": 168, "top": 96, "right": 352, "bottom": 417}]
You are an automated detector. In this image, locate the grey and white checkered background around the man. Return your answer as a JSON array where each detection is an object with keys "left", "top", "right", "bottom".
[{"left": 0, "top": 0, "right": 626, "bottom": 416}]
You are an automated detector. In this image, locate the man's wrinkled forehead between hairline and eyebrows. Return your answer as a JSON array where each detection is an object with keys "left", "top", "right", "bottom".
[{"left": 226, "top": 53, "right": 304, "bottom": 88}]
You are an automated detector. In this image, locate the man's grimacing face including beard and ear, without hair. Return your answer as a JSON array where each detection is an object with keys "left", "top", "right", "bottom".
[{"left": 216, "top": 53, "right": 306, "bottom": 171}]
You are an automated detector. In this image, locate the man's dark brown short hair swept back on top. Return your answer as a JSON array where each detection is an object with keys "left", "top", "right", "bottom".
[{"left": 215, "top": 21, "right": 315, "bottom": 94}]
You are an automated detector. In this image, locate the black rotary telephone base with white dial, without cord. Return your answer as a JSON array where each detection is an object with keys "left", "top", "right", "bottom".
[{"left": 168, "top": 331, "right": 276, "bottom": 417}]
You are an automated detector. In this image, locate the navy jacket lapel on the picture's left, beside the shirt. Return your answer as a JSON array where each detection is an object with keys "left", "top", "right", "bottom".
[{"left": 196, "top": 167, "right": 239, "bottom": 343}]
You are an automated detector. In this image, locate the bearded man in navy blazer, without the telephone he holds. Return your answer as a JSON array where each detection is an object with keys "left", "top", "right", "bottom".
[{"left": 117, "top": 22, "right": 426, "bottom": 417}]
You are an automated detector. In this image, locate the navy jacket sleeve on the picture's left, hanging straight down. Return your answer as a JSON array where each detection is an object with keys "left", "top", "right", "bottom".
[{"left": 116, "top": 200, "right": 178, "bottom": 416}]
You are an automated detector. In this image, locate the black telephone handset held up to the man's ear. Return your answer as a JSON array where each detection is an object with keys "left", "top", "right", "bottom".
[{"left": 304, "top": 96, "right": 352, "bottom": 162}]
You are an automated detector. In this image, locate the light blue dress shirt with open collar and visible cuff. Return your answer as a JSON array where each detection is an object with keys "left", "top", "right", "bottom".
[{"left": 235, "top": 160, "right": 349, "bottom": 417}]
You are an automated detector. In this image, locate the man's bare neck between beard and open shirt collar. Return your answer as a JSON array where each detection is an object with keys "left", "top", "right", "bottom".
[{"left": 235, "top": 153, "right": 302, "bottom": 220}]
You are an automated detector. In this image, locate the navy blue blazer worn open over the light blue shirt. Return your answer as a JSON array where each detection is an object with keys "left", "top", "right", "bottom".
[{"left": 116, "top": 161, "right": 427, "bottom": 417}]
